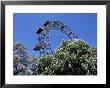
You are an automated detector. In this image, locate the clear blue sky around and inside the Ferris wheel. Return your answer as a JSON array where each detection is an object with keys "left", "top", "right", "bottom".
[{"left": 13, "top": 13, "right": 97, "bottom": 56}]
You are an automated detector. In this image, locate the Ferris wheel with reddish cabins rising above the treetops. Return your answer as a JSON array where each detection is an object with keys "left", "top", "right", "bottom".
[{"left": 33, "top": 20, "right": 78, "bottom": 55}]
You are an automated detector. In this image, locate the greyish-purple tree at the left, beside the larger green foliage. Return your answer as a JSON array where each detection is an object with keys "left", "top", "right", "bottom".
[{"left": 13, "top": 42, "right": 30, "bottom": 75}]
